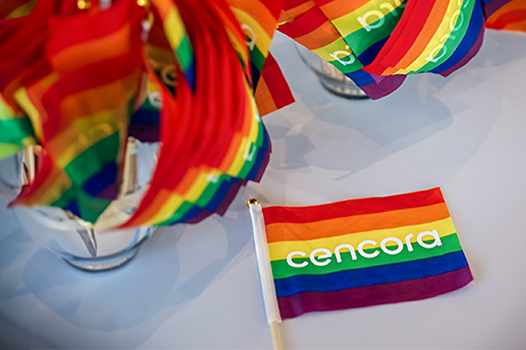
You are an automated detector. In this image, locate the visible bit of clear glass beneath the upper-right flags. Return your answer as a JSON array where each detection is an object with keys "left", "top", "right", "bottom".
[{"left": 294, "top": 44, "right": 369, "bottom": 100}]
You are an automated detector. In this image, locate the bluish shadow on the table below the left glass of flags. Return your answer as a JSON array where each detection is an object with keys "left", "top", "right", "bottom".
[{"left": 16, "top": 211, "right": 251, "bottom": 348}]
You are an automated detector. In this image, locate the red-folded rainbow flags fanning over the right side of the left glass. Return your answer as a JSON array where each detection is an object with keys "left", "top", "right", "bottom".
[{"left": 124, "top": 0, "right": 281, "bottom": 226}]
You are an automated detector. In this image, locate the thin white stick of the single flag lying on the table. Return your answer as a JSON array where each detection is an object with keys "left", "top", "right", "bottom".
[{"left": 247, "top": 198, "right": 283, "bottom": 350}]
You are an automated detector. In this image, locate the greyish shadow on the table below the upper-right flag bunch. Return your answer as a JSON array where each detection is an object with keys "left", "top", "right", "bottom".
[{"left": 264, "top": 29, "right": 512, "bottom": 197}]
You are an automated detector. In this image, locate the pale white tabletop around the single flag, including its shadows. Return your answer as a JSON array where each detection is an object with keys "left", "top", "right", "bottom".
[{"left": 0, "top": 31, "right": 526, "bottom": 349}]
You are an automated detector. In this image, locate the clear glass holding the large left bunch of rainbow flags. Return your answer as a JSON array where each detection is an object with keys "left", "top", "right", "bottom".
[{"left": 0, "top": 138, "right": 158, "bottom": 271}]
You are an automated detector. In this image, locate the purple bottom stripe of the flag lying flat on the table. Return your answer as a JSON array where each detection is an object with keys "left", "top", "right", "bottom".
[{"left": 278, "top": 266, "right": 473, "bottom": 319}]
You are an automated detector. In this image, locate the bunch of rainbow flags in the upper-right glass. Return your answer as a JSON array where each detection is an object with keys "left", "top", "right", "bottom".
[{"left": 279, "top": 0, "right": 510, "bottom": 99}]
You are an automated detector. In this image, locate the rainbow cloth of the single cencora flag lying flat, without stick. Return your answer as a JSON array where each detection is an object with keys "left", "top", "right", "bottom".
[{"left": 263, "top": 188, "right": 473, "bottom": 319}]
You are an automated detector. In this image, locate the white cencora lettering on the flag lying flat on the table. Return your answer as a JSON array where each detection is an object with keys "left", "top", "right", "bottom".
[{"left": 287, "top": 230, "right": 442, "bottom": 268}]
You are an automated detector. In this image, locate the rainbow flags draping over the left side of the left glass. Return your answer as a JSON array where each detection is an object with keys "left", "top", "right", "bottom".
[{"left": 0, "top": 0, "right": 146, "bottom": 222}]
